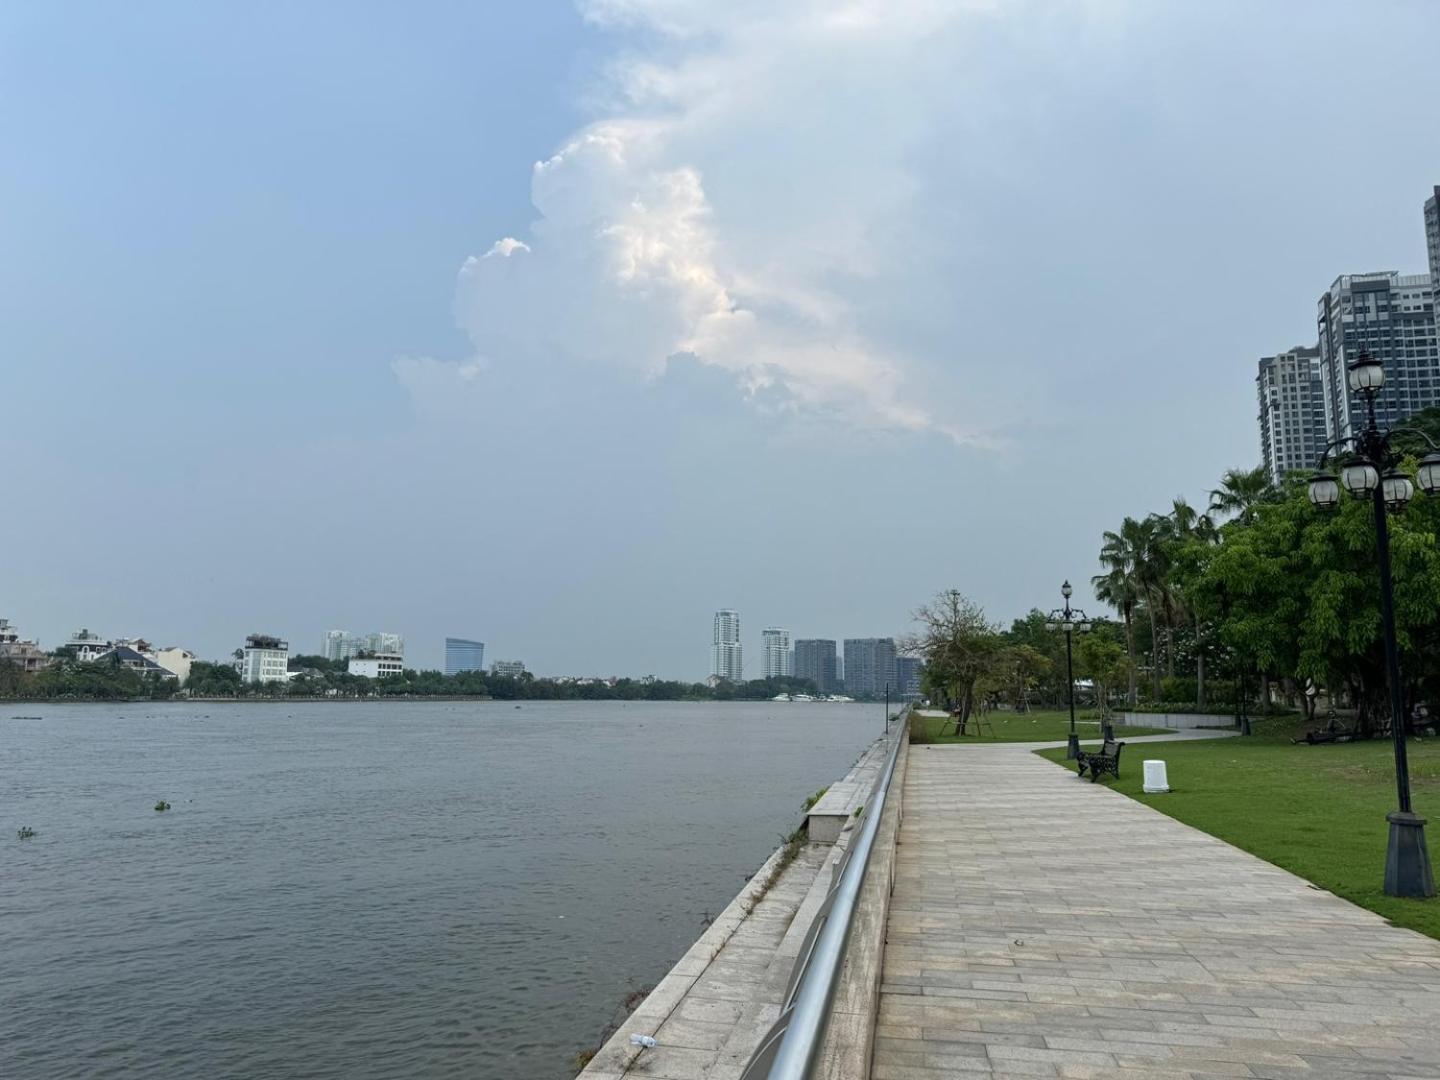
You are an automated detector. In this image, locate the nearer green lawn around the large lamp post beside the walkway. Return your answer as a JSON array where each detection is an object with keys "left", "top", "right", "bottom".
[{"left": 1037, "top": 719, "right": 1440, "bottom": 937}]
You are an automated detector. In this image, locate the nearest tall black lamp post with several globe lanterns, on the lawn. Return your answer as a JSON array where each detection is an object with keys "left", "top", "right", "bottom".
[{"left": 1310, "top": 350, "right": 1440, "bottom": 897}]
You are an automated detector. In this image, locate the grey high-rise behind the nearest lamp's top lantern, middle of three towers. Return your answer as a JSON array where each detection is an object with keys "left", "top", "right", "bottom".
[{"left": 1316, "top": 271, "right": 1440, "bottom": 439}]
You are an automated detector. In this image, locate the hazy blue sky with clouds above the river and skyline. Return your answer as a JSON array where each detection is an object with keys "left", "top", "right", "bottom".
[{"left": 8, "top": 0, "right": 1440, "bottom": 678}]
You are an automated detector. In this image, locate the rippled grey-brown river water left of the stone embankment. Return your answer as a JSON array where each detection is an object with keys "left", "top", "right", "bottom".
[{"left": 0, "top": 703, "right": 881, "bottom": 1080}]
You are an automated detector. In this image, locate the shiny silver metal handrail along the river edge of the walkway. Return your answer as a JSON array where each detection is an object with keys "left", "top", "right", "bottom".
[{"left": 740, "top": 721, "right": 904, "bottom": 1080}]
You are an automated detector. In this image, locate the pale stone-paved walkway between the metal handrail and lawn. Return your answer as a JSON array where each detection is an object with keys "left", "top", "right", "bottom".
[{"left": 873, "top": 744, "right": 1440, "bottom": 1080}]
